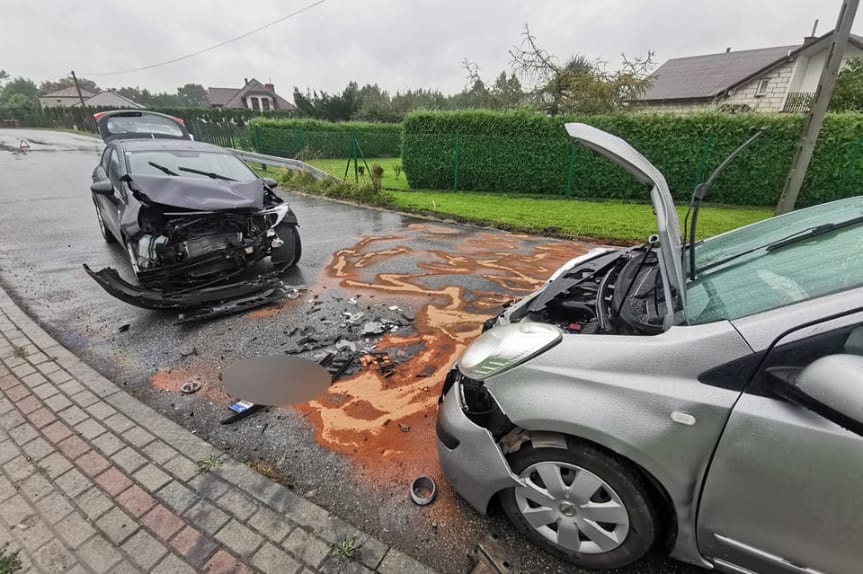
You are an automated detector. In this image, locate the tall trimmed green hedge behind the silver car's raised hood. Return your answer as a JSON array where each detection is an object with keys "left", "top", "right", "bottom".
[{"left": 402, "top": 111, "right": 863, "bottom": 205}]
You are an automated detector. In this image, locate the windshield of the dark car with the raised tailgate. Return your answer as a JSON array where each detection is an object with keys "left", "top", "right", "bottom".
[{"left": 126, "top": 150, "right": 257, "bottom": 182}]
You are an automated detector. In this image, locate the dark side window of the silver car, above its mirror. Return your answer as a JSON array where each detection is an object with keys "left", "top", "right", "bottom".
[{"left": 747, "top": 313, "right": 863, "bottom": 396}]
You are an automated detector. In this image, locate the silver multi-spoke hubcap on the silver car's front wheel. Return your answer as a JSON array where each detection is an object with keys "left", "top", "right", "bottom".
[{"left": 515, "top": 461, "right": 629, "bottom": 554}]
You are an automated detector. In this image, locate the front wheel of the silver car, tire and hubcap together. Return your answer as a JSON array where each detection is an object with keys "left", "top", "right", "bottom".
[{"left": 500, "top": 441, "right": 659, "bottom": 569}]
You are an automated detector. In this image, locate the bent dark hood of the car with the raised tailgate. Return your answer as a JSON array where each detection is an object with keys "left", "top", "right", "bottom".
[{"left": 129, "top": 175, "right": 264, "bottom": 211}]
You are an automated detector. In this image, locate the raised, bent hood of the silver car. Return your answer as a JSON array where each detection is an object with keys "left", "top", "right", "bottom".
[{"left": 566, "top": 123, "right": 686, "bottom": 324}]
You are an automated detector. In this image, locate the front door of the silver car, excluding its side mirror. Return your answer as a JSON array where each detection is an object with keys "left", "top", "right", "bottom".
[{"left": 698, "top": 312, "right": 863, "bottom": 574}]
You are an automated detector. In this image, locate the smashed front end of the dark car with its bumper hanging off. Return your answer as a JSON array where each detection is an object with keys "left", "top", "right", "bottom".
[{"left": 84, "top": 199, "right": 299, "bottom": 322}]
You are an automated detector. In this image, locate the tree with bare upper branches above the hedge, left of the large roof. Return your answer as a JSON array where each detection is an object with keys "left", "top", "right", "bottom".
[{"left": 509, "top": 26, "right": 655, "bottom": 115}]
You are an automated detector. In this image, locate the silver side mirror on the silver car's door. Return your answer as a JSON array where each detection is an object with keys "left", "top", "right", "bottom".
[{"left": 786, "top": 355, "right": 863, "bottom": 434}]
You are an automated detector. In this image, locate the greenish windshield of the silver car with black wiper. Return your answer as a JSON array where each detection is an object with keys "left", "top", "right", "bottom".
[{"left": 687, "top": 197, "right": 863, "bottom": 324}]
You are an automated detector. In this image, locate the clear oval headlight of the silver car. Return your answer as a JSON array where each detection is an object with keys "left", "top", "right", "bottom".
[{"left": 458, "top": 321, "right": 563, "bottom": 380}]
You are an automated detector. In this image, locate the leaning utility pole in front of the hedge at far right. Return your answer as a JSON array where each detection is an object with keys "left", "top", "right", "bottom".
[{"left": 776, "top": 0, "right": 860, "bottom": 215}]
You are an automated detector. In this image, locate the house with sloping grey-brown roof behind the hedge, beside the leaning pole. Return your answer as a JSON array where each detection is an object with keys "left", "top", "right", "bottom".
[{"left": 636, "top": 32, "right": 863, "bottom": 113}]
